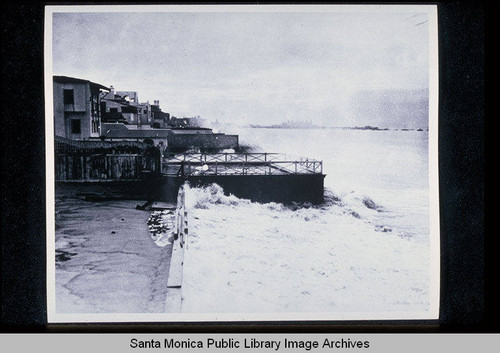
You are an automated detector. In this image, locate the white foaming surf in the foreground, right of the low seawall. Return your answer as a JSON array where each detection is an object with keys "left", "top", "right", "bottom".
[{"left": 183, "top": 184, "right": 428, "bottom": 312}]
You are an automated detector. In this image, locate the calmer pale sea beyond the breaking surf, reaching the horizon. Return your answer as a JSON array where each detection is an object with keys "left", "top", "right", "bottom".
[{"left": 239, "top": 129, "right": 429, "bottom": 241}]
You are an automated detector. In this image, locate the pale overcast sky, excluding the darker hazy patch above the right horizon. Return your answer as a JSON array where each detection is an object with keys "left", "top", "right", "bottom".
[{"left": 53, "top": 6, "right": 429, "bottom": 125}]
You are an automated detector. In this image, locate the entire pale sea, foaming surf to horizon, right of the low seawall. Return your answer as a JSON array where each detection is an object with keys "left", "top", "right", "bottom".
[{"left": 182, "top": 128, "right": 431, "bottom": 318}]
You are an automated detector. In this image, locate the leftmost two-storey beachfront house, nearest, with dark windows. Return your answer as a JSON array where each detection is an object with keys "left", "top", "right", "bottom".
[{"left": 53, "top": 76, "right": 110, "bottom": 140}]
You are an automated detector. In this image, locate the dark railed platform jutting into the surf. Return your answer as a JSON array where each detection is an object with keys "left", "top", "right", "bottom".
[{"left": 160, "top": 153, "right": 325, "bottom": 204}]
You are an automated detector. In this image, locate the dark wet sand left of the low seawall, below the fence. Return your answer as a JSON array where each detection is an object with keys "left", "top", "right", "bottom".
[{"left": 55, "top": 192, "right": 172, "bottom": 313}]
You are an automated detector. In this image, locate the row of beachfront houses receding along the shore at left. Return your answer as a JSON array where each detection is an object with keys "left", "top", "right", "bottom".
[{"left": 53, "top": 76, "right": 238, "bottom": 149}]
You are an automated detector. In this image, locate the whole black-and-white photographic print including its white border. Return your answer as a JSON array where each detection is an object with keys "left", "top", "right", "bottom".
[{"left": 44, "top": 5, "right": 440, "bottom": 323}]
